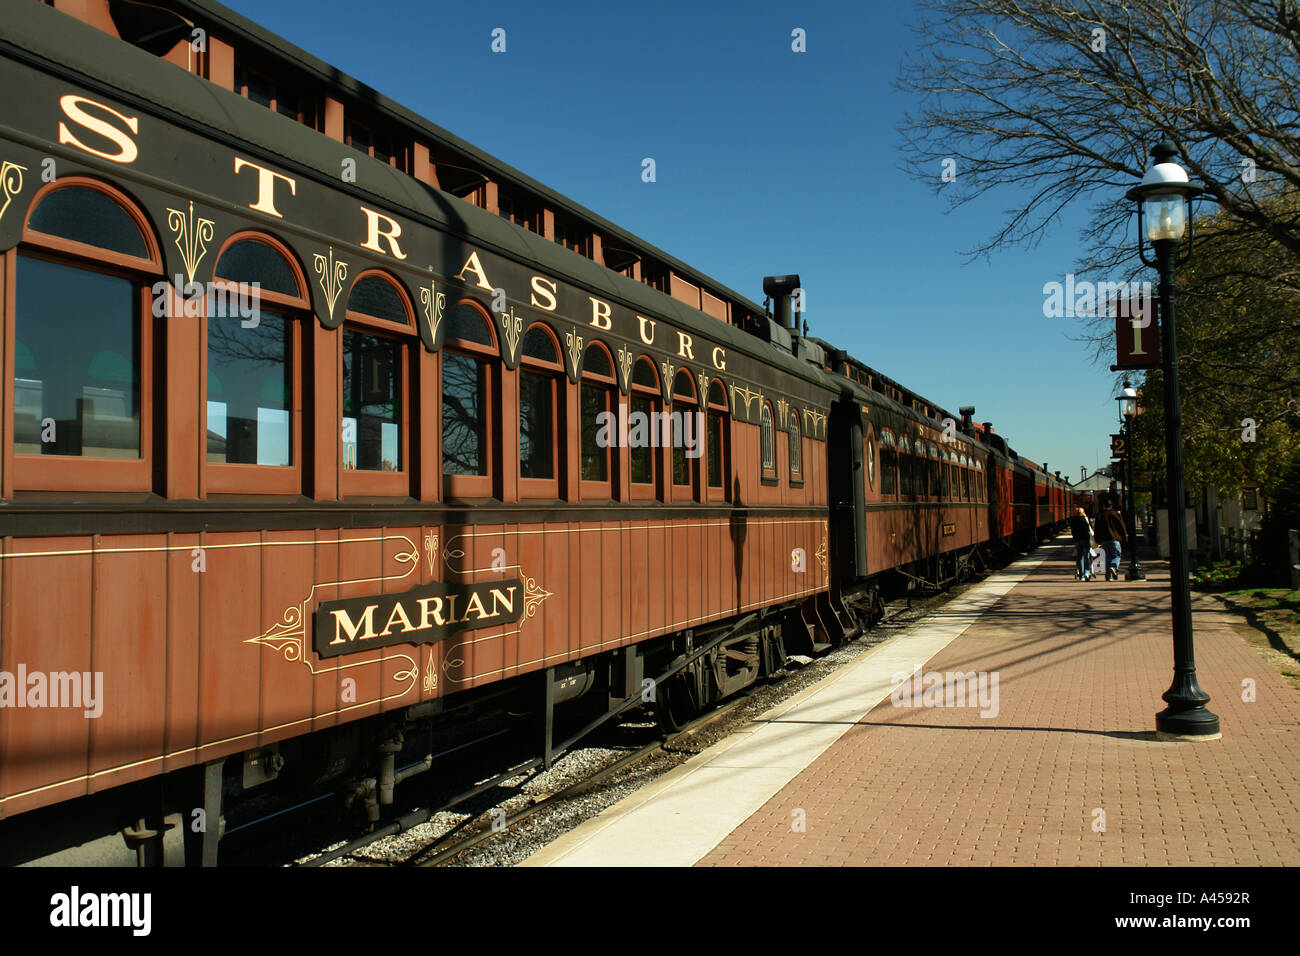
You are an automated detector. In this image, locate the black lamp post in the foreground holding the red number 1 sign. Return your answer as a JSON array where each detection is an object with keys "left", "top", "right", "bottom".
[{"left": 1125, "top": 142, "right": 1219, "bottom": 740}]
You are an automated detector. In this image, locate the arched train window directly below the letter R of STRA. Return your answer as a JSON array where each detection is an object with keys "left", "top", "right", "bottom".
[{"left": 342, "top": 271, "right": 415, "bottom": 494}]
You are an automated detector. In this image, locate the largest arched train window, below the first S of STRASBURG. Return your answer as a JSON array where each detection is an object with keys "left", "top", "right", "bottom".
[{"left": 14, "top": 177, "right": 161, "bottom": 492}]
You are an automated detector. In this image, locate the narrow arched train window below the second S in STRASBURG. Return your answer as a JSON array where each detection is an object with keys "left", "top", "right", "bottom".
[{"left": 519, "top": 323, "right": 564, "bottom": 498}]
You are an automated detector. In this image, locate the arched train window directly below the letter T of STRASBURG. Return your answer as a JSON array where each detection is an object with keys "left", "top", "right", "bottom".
[{"left": 203, "top": 233, "right": 311, "bottom": 494}]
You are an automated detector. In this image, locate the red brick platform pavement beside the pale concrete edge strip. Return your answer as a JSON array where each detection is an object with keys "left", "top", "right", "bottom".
[{"left": 699, "top": 545, "right": 1300, "bottom": 866}]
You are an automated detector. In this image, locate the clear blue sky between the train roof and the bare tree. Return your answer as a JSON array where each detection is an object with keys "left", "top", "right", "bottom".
[{"left": 226, "top": 0, "right": 1138, "bottom": 480}]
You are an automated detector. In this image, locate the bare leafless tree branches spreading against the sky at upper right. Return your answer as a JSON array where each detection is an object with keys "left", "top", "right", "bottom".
[{"left": 900, "top": 0, "right": 1300, "bottom": 293}]
